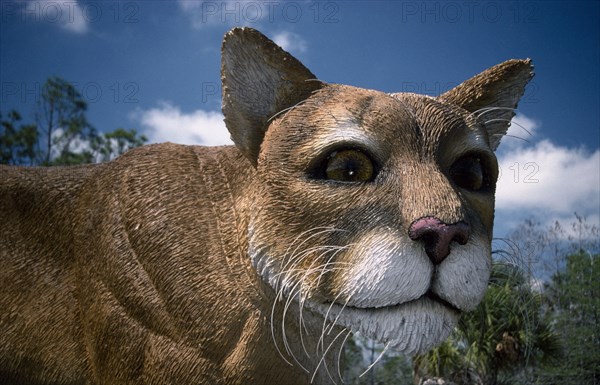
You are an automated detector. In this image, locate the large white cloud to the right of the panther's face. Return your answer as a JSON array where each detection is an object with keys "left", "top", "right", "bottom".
[{"left": 496, "top": 114, "right": 600, "bottom": 228}]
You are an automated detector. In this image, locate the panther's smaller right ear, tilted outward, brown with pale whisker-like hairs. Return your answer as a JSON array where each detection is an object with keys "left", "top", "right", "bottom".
[{"left": 438, "top": 59, "right": 533, "bottom": 150}]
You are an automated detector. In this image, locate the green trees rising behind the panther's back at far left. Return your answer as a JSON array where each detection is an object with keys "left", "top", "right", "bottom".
[{"left": 0, "top": 77, "right": 147, "bottom": 166}]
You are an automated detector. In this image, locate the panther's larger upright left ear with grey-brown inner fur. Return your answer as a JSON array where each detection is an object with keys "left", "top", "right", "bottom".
[{"left": 221, "top": 28, "right": 322, "bottom": 166}]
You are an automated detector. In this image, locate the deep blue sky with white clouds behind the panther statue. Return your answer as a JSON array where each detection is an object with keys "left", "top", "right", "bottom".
[{"left": 0, "top": 0, "right": 600, "bottom": 236}]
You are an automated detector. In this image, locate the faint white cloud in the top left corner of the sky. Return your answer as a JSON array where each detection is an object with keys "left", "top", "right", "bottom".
[{"left": 22, "top": 0, "right": 89, "bottom": 34}]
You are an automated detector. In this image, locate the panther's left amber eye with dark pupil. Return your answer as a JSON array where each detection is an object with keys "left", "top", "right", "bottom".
[{"left": 323, "top": 150, "right": 375, "bottom": 182}]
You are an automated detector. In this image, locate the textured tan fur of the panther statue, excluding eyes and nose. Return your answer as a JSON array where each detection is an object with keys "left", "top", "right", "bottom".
[{"left": 0, "top": 29, "right": 531, "bottom": 384}]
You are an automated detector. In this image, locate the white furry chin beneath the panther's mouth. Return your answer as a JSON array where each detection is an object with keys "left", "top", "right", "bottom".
[{"left": 306, "top": 293, "right": 461, "bottom": 355}]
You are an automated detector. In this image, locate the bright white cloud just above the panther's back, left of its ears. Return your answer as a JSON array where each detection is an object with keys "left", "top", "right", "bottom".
[{"left": 132, "top": 103, "right": 233, "bottom": 146}]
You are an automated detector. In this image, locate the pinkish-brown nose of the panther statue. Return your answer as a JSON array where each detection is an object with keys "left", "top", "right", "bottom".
[{"left": 408, "top": 217, "right": 471, "bottom": 265}]
